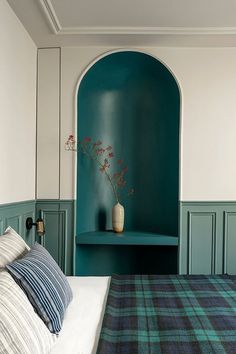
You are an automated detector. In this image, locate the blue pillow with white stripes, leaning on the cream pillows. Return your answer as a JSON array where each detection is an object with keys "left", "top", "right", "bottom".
[{"left": 7, "top": 243, "right": 72, "bottom": 333}]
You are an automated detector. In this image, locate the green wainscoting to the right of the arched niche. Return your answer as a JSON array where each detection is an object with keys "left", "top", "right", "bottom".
[{"left": 179, "top": 201, "right": 236, "bottom": 274}]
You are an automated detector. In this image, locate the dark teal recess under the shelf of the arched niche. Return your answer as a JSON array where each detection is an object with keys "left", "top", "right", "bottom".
[{"left": 76, "top": 245, "right": 177, "bottom": 276}]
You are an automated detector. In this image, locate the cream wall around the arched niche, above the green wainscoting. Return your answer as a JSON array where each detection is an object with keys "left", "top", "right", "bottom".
[{"left": 60, "top": 47, "right": 236, "bottom": 201}]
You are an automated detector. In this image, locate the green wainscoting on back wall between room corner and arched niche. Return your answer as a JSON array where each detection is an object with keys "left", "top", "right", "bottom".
[{"left": 36, "top": 199, "right": 75, "bottom": 275}]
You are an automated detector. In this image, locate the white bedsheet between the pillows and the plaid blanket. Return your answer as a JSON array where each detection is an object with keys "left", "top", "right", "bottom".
[{"left": 51, "top": 277, "right": 110, "bottom": 354}]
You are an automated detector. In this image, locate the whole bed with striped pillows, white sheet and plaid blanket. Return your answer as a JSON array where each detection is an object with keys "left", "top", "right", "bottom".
[{"left": 0, "top": 228, "right": 236, "bottom": 354}]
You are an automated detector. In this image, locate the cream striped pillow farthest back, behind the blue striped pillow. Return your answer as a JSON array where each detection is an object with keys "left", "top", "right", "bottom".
[{"left": 0, "top": 227, "right": 30, "bottom": 269}]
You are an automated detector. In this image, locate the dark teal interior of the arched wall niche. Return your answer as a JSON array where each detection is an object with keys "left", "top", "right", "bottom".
[{"left": 76, "top": 51, "right": 180, "bottom": 274}]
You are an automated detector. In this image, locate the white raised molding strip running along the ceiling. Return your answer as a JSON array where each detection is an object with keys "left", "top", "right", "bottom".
[{"left": 39, "top": 0, "right": 236, "bottom": 35}]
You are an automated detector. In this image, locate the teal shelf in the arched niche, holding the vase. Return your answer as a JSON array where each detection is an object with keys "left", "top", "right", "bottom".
[{"left": 76, "top": 231, "right": 179, "bottom": 246}]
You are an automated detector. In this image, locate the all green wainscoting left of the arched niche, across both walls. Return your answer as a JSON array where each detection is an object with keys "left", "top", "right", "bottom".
[{"left": 0, "top": 199, "right": 75, "bottom": 275}]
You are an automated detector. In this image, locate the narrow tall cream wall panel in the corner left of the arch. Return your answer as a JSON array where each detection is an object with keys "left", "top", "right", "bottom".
[{"left": 37, "top": 48, "right": 60, "bottom": 199}]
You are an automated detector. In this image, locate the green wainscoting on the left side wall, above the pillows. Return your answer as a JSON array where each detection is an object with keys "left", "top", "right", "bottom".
[{"left": 0, "top": 200, "right": 35, "bottom": 246}]
